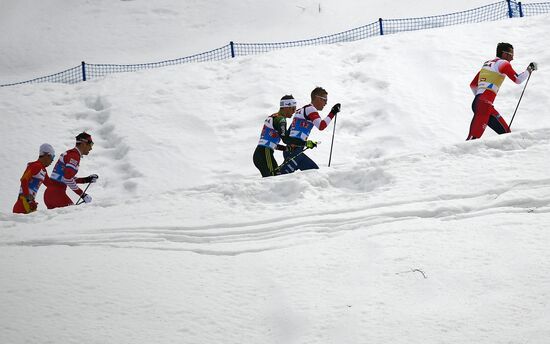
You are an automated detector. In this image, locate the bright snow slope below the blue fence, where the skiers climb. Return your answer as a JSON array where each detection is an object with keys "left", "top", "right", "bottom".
[{"left": 0, "top": 1, "right": 550, "bottom": 344}]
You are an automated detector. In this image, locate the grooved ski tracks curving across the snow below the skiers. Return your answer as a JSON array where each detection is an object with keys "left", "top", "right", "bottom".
[{"left": 6, "top": 189, "right": 550, "bottom": 255}]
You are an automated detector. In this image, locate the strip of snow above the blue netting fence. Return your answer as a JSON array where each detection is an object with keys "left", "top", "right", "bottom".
[{"left": 0, "top": 0, "right": 490, "bottom": 85}]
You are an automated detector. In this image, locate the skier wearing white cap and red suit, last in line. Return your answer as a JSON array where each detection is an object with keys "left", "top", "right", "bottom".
[{"left": 13, "top": 143, "right": 55, "bottom": 214}]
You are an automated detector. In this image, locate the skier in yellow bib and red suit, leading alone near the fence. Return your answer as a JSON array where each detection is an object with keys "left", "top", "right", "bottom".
[{"left": 466, "top": 43, "right": 537, "bottom": 140}]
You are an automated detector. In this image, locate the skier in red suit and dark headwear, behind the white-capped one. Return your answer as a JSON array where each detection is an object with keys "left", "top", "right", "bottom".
[{"left": 44, "top": 132, "right": 98, "bottom": 209}]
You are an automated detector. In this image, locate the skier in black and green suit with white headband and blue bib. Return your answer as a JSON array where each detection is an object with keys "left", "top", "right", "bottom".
[{"left": 253, "top": 95, "right": 296, "bottom": 177}]
